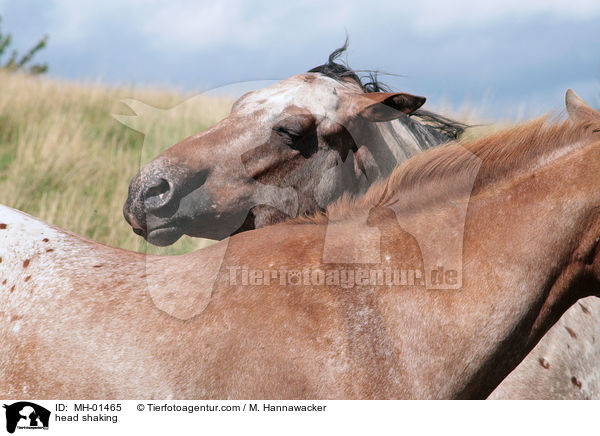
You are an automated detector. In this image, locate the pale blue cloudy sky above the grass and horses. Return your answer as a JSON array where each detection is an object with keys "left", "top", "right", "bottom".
[{"left": 0, "top": 0, "right": 600, "bottom": 118}]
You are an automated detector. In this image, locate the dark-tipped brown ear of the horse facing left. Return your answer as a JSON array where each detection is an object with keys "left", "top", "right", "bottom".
[{"left": 357, "top": 92, "right": 426, "bottom": 122}]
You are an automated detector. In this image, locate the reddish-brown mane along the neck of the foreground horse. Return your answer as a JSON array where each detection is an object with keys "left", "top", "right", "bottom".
[{"left": 288, "top": 117, "right": 600, "bottom": 223}]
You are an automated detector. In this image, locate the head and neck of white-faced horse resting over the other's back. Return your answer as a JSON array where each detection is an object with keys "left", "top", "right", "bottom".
[{"left": 123, "top": 41, "right": 464, "bottom": 245}]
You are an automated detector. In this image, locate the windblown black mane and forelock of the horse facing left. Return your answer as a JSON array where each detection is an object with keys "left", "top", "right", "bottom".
[{"left": 308, "top": 38, "right": 468, "bottom": 139}]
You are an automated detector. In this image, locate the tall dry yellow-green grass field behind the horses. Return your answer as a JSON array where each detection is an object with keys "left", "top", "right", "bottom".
[{"left": 0, "top": 72, "right": 491, "bottom": 254}]
